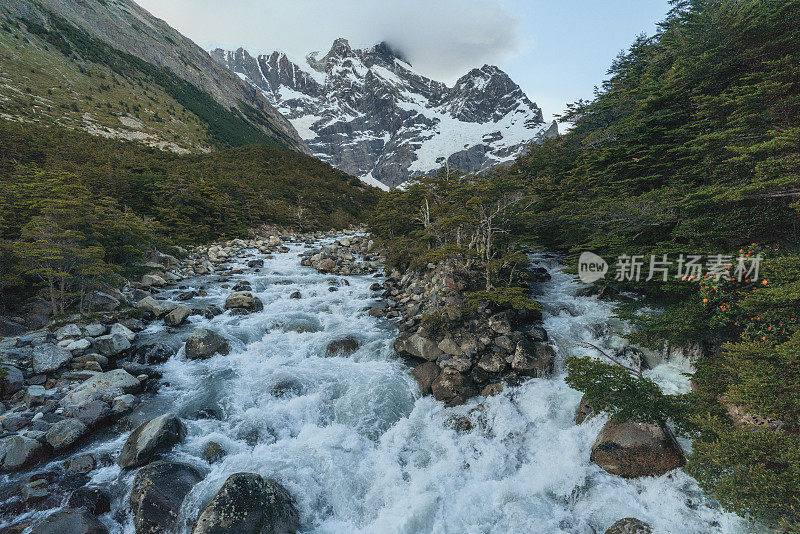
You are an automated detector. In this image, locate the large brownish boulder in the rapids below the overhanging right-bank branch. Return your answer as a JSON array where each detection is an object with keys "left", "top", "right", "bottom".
[{"left": 591, "top": 421, "right": 686, "bottom": 478}]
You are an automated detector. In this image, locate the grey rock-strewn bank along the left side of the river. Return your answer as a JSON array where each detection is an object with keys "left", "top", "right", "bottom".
[{"left": 0, "top": 233, "right": 352, "bottom": 532}]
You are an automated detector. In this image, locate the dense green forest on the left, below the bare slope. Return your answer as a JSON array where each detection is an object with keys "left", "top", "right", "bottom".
[{"left": 0, "top": 120, "right": 381, "bottom": 314}]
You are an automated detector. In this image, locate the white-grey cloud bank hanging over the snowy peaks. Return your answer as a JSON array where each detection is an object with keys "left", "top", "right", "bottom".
[{"left": 136, "top": 0, "right": 520, "bottom": 82}]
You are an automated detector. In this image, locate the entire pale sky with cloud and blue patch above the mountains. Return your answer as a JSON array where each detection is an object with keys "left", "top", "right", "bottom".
[{"left": 136, "top": 0, "right": 669, "bottom": 122}]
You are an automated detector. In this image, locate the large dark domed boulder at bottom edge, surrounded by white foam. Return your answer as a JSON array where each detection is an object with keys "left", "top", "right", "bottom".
[{"left": 192, "top": 473, "right": 300, "bottom": 534}]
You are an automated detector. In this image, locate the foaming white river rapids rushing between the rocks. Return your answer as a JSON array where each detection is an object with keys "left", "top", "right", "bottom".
[{"left": 61, "top": 244, "right": 747, "bottom": 534}]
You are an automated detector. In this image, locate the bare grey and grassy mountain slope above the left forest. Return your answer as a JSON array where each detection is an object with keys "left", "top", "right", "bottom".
[{"left": 0, "top": 0, "right": 309, "bottom": 153}]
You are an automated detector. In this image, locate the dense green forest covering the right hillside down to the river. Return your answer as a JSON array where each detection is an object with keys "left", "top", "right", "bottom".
[{"left": 373, "top": 0, "right": 800, "bottom": 530}]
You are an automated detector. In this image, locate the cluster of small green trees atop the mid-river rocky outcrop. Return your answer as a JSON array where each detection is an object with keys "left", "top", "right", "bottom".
[{"left": 370, "top": 170, "right": 539, "bottom": 310}]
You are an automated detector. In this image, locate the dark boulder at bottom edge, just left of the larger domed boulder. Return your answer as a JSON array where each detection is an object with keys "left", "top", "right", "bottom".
[{"left": 130, "top": 461, "right": 203, "bottom": 534}]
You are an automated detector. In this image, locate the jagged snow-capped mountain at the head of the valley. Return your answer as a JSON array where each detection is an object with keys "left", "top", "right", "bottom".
[{"left": 211, "top": 39, "right": 558, "bottom": 186}]
